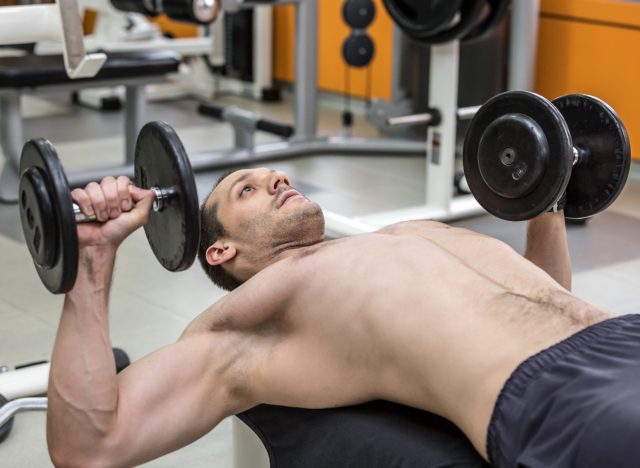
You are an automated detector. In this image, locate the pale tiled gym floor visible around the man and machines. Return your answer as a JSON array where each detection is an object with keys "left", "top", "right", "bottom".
[{"left": 0, "top": 89, "right": 640, "bottom": 468}]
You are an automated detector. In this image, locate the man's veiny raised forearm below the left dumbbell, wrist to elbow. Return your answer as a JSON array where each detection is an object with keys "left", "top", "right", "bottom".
[{"left": 47, "top": 246, "right": 118, "bottom": 461}]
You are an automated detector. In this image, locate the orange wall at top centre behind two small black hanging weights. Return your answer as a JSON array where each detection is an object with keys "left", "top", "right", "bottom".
[{"left": 273, "top": 0, "right": 393, "bottom": 99}]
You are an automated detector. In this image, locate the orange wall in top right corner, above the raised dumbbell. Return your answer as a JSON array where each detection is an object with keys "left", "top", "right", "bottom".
[{"left": 536, "top": 0, "right": 640, "bottom": 159}]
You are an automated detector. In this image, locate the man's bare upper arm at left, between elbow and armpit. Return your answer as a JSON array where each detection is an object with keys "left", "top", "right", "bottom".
[{"left": 109, "top": 333, "right": 242, "bottom": 464}]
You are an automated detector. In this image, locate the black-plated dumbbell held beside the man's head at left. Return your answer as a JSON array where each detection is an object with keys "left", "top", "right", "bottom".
[{"left": 19, "top": 122, "right": 200, "bottom": 294}]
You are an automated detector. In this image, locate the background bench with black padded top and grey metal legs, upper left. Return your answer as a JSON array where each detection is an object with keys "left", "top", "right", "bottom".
[{"left": 0, "top": 51, "right": 180, "bottom": 202}]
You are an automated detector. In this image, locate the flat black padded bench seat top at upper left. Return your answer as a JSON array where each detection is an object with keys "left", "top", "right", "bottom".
[{"left": 0, "top": 50, "right": 180, "bottom": 88}]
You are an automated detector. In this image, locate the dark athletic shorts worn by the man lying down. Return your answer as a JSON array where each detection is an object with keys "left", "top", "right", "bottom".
[{"left": 487, "top": 315, "right": 640, "bottom": 468}]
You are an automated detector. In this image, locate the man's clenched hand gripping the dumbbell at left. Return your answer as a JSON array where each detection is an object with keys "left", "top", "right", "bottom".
[{"left": 71, "top": 176, "right": 154, "bottom": 250}]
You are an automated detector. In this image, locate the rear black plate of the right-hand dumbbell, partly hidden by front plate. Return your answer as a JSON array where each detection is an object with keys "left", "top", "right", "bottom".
[{"left": 553, "top": 94, "right": 631, "bottom": 219}]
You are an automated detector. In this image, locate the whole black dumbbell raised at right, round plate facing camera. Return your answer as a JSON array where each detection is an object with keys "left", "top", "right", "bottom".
[{"left": 463, "top": 91, "right": 631, "bottom": 221}]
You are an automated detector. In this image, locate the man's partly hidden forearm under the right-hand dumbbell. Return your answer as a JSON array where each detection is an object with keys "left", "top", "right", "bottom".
[{"left": 524, "top": 212, "right": 571, "bottom": 291}]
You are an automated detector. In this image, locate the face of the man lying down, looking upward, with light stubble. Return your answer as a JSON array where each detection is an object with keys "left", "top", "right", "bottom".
[{"left": 210, "top": 168, "right": 324, "bottom": 257}]
